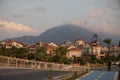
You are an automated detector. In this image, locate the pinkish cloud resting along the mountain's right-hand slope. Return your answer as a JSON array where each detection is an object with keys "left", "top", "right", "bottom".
[{"left": 70, "top": 19, "right": 120, "bottom": 35}]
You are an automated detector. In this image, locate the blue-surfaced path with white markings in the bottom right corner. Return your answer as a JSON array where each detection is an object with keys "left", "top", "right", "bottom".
[{"left": 76, "top": 71, "right": 118, "bottom": 80}]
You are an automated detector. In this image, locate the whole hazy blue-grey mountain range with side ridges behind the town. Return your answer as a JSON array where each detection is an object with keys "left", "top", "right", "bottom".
[{"left": 5, "top": 24, "right": 120, "bottom": 44}]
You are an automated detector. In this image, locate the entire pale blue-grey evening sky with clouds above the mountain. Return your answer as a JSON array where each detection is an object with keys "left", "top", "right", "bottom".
[{"left": 0, "top": 0, "right": 120, "bottom": 40}]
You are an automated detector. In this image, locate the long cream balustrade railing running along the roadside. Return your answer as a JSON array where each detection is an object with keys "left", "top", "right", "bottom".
[{"left": 0, "top": 56, "right": 90, "bottom": 71}]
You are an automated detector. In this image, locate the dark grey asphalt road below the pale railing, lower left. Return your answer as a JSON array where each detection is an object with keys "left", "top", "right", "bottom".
[{"left": 0, "top": 68, "right": 70, "bottom": 80}]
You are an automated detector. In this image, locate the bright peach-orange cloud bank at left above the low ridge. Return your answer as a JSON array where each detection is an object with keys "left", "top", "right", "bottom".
[{"left": 0, "top": 20, "right": 39, "bottom": 38}]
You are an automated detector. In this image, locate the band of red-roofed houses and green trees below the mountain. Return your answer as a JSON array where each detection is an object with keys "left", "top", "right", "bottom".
[{"left": 0, "top": 34, "right": 120, "bottom": 65}]
